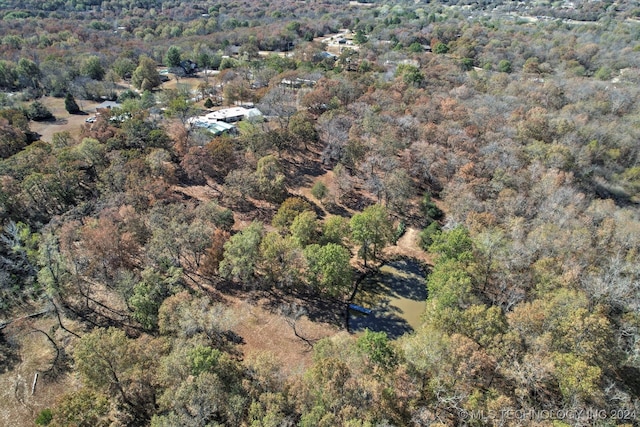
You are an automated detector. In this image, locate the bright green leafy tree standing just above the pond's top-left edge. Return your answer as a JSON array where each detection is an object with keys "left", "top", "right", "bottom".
[{"left": 349, "top": 205, "right": 394, "bottom": 267}]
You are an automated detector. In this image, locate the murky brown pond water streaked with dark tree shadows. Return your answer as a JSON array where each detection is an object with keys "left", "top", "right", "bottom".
[{"left": 349, "top": 260, "right": 427, "bottom": 338}]
